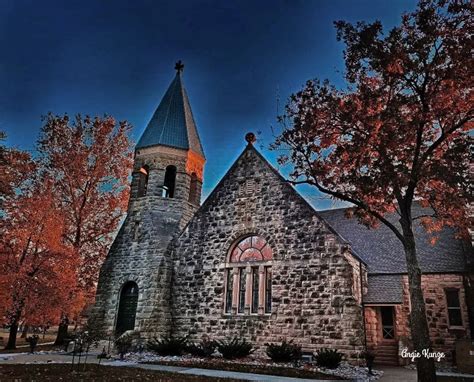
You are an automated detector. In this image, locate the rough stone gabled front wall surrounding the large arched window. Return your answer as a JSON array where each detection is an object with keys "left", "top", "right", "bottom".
[{"left": 172, "top": 146, "right": 363, "bottom": 359}]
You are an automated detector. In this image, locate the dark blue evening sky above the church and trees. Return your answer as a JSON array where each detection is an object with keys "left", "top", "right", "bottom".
[{"left": 0, "top": 0, "right": 415, "bottom": 208}]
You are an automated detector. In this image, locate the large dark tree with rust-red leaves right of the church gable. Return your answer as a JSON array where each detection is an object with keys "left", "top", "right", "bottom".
[{"left": 273, "top": 0, "right": 474, "bottom": 381}]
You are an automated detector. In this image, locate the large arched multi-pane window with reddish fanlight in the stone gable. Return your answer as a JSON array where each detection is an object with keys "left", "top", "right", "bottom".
[{"left": 224, "top": 235, "right": 273, "bottom": 314}]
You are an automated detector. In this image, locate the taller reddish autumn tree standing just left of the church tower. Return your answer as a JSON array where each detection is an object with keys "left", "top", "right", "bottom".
[{"left": 38, "top": 114, "right": 132, "bottom": 344}]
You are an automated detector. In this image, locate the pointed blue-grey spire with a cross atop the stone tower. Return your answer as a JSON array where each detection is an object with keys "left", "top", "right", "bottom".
[{"left": 135, "top": 60, "right": 205, "bottom": 158}]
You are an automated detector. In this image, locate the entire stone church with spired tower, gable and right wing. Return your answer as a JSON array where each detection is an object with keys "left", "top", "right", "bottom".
[{"left": 92, "top": 63, "right": 470, "bottom": 364}]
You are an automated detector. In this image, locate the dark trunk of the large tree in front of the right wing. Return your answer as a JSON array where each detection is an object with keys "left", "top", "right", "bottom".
[{"left": 400, "top": 218, "right": 436, "bottom": 382}]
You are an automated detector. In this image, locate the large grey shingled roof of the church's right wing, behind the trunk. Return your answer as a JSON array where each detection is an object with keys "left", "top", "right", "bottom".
[{"left": 319, "top": 205, "right": 465, "bottom": 274}]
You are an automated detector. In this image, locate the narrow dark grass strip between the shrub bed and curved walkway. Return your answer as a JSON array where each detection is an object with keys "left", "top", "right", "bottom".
[{"left": 146, "top": 360, "right": 343, "bottom": 380}]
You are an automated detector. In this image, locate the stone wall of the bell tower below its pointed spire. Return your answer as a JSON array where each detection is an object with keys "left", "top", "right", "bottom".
[{"left": 91, "top": 147, "right": 202, "bottom": 337}]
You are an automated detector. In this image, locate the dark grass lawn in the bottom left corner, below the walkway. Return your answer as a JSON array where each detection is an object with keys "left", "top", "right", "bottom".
[{"left": 0, "top": 364, "right": 241, "bottom": 382}]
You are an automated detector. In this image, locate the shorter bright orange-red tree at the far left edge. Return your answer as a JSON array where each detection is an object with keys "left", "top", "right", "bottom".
[{"left": 0, "top": 179, "right": 77, "bottom": 349}]
